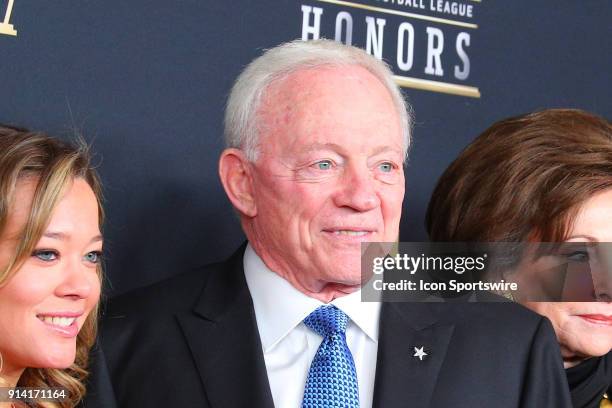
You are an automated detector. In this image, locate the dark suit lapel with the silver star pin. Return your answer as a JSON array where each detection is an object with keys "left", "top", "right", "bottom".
[{"left": 372, "top": 303, "right": 454, "bottom": 408}]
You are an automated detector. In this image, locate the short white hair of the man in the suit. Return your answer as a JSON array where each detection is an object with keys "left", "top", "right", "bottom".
[{"left": 224, "top": 40, "right": 412, "bottom": 161}]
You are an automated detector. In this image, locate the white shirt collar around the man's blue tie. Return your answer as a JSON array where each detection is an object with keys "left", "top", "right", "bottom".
[{"left": 243, "top": 244, "right": 380, "bottom": 352}]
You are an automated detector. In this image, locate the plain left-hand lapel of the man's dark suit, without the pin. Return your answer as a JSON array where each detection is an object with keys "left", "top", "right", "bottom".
[{"left": 177, "top": 247, "right": 273, "bottom": 408}]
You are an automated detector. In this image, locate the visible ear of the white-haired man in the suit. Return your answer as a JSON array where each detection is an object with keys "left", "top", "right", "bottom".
[{"left": 219, "top": 148, "right": 257, "bottom": 217}]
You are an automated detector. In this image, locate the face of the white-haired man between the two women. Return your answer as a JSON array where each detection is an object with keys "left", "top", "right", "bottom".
[{"left": 249, "top": 67, "right": 404, "bottom": 297}]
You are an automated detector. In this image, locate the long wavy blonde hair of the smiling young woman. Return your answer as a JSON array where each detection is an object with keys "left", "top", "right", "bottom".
[{"left": 0, "top": 125, "right": 104, "bottom": 408}]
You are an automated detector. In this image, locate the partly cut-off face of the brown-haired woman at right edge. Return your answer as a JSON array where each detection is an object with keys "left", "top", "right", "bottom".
[{"left": 526, "top": 189, "right": 612, "bottom": 366}]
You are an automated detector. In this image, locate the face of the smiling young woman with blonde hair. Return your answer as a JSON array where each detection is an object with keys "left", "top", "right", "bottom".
[{"left": 0, "top": 178, "right": 102, "bottom": 373}]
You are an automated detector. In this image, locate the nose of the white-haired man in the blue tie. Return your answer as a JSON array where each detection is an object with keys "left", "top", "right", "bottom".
[{"left": 334, "top": 165, "right": 380, "bottom": 212}]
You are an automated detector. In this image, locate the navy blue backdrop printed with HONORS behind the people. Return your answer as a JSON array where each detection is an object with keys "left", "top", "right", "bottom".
[{"left": 0, "top": 0, "right": 612, "bottom": 294}]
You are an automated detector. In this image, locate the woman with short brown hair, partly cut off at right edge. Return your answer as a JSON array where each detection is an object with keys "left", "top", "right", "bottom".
[{"left": 426, "top": 109, "right": 612, "bottom": 408}]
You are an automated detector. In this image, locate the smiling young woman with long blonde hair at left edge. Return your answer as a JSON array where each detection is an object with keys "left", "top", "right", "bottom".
[{"left": 0, "top": 126, "right": 103, "bottom": 408}]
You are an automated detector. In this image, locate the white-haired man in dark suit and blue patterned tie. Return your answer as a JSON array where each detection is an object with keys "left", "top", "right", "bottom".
[{"left": 92, "top": 41, "right": 569, "bottom": 408}]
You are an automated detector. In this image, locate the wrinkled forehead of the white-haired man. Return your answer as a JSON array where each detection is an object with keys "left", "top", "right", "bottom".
[{"left": 257, "top": 66, "right": 403, "bottom": 155}]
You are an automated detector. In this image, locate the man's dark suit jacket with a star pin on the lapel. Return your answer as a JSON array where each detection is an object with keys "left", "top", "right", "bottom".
[{"left": 87, "top": 247, "right": 571, "bottom": 408}]
